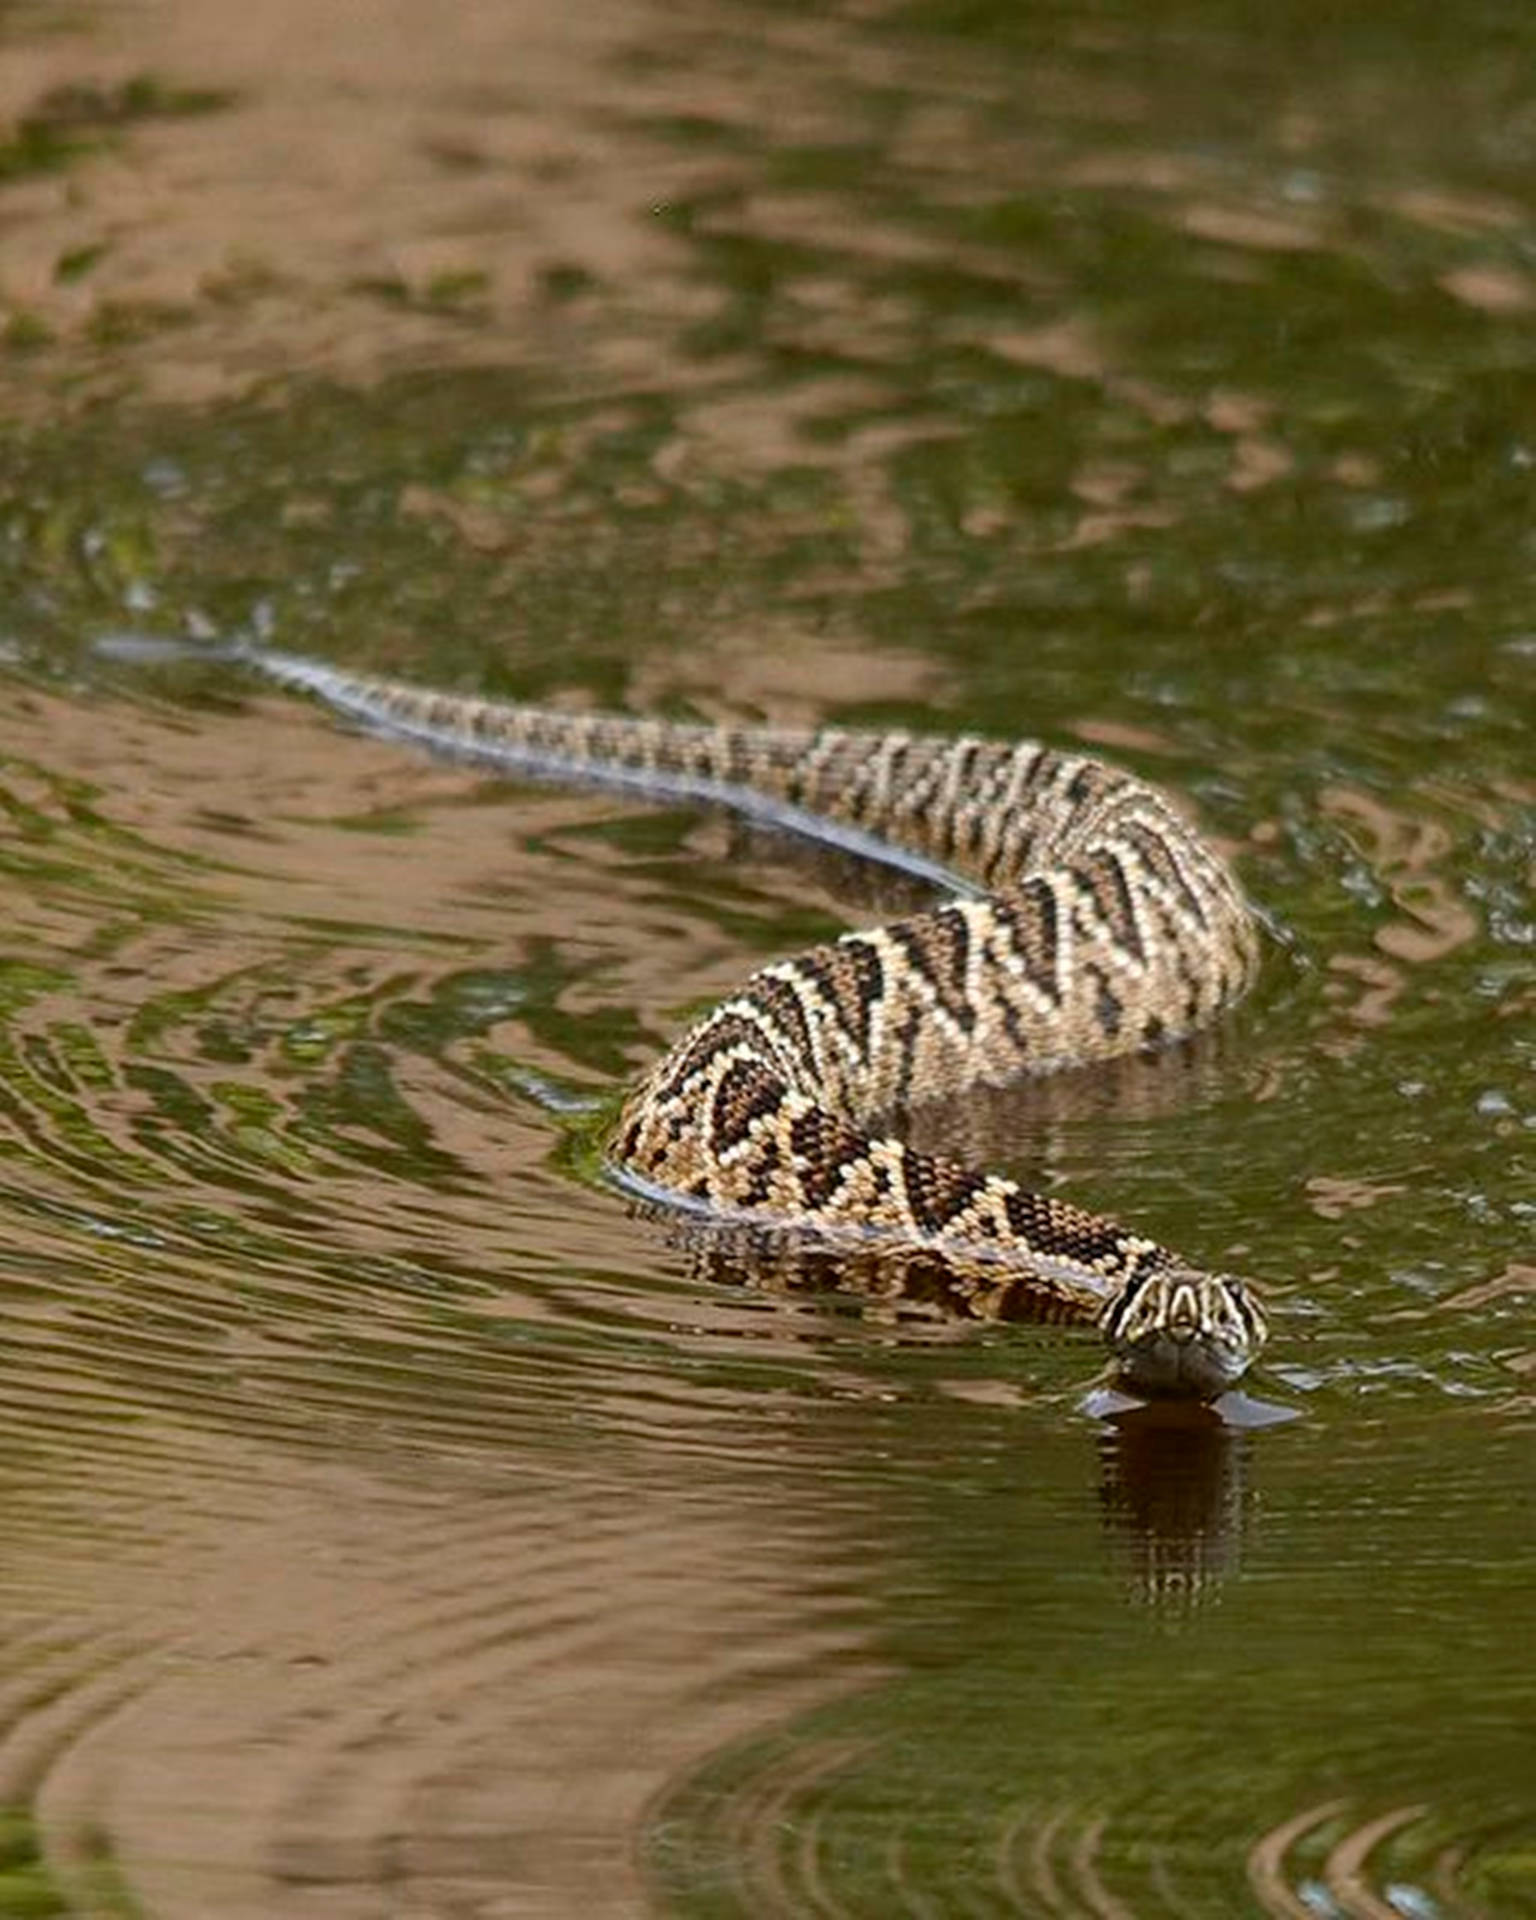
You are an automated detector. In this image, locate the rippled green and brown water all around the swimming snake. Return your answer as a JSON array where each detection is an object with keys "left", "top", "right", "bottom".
[{"left": 0, "top": 0, "right": 1536, "bottom": 1920}]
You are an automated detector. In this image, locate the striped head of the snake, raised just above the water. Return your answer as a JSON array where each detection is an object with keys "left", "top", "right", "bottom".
[{"left": 1098, "top": 1267, "right": 1269, "bottom": 1400}]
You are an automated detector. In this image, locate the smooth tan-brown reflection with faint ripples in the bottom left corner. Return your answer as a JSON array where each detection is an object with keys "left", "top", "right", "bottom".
[{"left": 0, "top": 1361, "right": 883, "bottom": 1916}]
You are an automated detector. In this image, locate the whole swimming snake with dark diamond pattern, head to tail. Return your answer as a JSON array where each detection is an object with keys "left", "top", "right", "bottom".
[{"left": 117, "top": 643, "right": 1267, "bottom": 1400}]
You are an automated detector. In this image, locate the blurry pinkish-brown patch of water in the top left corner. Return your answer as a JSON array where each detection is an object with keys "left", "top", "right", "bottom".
[{"left": 0, "top": 0, "right": 697, "bottom": 401}]
